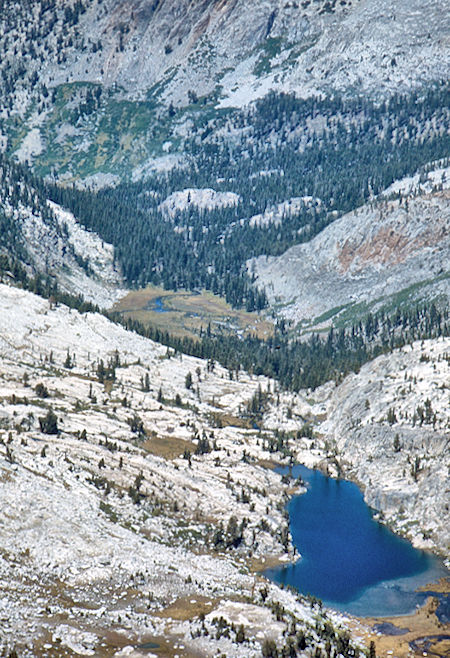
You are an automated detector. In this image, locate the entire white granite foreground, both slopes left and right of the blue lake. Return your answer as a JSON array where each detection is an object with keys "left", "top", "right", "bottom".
[{"left": 0, "top": 285, "right": 450, "bottom": 657}]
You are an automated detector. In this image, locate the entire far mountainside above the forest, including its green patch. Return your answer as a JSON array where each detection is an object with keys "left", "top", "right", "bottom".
[{"left": 0, "top": 0, "right": 449, "bottom": 179}]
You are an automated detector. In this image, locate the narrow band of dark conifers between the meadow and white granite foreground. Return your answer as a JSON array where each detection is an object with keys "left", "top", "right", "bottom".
[{"left": 118, "top": 303, "right": 450, "bottom": 390}]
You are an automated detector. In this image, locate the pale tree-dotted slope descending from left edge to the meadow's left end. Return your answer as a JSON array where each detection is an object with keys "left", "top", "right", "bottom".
[{"left": 0, "top": 156, "right": 125, "bottom": 308}]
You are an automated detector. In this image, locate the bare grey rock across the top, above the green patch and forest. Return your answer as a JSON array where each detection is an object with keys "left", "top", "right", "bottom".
[{"left": 0, "top": 0, "right": 450, "bottom": 111}]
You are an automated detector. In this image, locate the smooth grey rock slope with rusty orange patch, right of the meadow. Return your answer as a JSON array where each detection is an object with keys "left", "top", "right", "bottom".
[{"left": 250, "top": 191, "right": 450, "bottom": 322}]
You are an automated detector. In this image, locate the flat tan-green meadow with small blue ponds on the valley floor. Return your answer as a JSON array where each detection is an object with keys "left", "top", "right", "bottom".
[{"left": 114, "top": 286, "right": 273, "bottom": 338}]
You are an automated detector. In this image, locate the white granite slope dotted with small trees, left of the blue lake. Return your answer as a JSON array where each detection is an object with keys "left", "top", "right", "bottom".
[{"left": 0, "top": 284, "right": 364, "bottom": 658}]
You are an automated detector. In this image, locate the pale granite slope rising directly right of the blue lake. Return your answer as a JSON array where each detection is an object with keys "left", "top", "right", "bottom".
[{"left": 321, "top": 338, "right": 450, "bottom": 558}]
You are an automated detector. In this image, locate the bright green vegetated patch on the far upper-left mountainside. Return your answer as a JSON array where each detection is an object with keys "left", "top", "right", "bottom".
[{"left": 6, "top": 75, "right": 230, "bottom": 179}]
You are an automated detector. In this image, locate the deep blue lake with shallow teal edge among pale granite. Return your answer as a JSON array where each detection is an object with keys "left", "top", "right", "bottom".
[{"left": 266, "top": 465, "right": 450, "bottom": 616}]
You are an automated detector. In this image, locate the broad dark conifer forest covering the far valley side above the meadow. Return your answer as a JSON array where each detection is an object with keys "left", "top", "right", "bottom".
[{"left": 50, "top": 85, "right": 450, "bottom": 310}]
